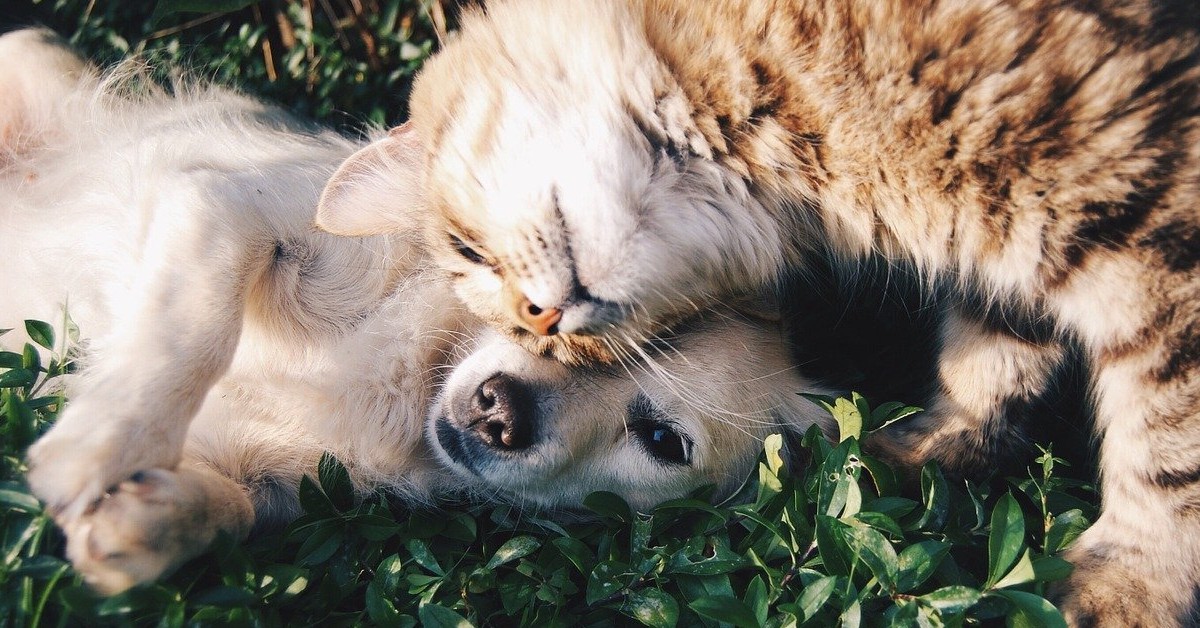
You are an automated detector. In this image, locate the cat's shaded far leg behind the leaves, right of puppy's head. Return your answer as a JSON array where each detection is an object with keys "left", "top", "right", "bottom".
[{"left": 868, "top": 309, "right": 1064, "bottom": 474}]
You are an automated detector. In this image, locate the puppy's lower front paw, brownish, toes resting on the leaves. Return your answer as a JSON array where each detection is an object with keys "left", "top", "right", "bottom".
[{"left": 64, "top": 468, "right": 248, "bottom": 594}]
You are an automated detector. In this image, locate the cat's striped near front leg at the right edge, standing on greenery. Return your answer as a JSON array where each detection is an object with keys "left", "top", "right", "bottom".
[{"left": 1057, "top": 264, "right": 1200, "bottom": 627}]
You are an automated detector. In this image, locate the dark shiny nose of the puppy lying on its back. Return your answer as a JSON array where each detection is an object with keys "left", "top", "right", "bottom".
[{"left": 467, "top": 373, "right": 534, "bottom": 451}]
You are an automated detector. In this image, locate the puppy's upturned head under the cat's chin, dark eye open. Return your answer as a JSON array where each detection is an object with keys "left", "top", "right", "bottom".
[{"left": 427, "top": 315, "right": 828, "bottom": 508}]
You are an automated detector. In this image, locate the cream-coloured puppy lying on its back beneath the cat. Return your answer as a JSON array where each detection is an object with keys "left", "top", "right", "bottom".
[{"left": 0, "top": 30, "right": 818, "bottom": 592}]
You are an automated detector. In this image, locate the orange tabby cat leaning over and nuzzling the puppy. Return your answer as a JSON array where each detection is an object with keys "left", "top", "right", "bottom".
[{"left": 320, "top": 0, "right": 1200, "bottom": 626}]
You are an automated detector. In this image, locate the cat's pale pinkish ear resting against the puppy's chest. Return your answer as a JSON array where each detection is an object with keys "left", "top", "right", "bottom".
[{"left": 317, "top": 124, "right": 425, "bottom": 235}]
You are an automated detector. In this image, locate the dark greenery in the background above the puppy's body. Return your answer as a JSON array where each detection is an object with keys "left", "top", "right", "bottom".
[{"left": 15, "top": 0, "right": 454, "bottom": 128}]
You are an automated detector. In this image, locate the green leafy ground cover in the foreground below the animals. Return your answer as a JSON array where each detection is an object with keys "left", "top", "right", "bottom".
[{"left": 0, "top": 322, "right": 1094, "bottom": 627}]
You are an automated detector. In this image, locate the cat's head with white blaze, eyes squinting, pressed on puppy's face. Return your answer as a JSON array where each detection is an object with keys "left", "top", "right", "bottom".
[{"left": 318, "top": 0, "right": 781, "bottom": 363}]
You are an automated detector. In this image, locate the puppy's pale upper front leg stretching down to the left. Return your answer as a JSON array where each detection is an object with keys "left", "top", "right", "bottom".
[{"left": 29, "top": 189, "right": 270, "bottom": 526}]
